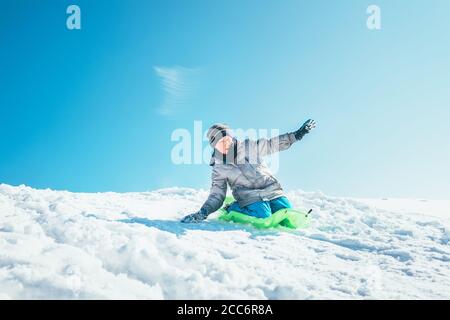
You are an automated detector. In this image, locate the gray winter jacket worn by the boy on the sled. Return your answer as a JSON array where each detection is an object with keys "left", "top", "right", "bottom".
[{"left": 202, "top": 133, "right": 297, "bottom": 214}]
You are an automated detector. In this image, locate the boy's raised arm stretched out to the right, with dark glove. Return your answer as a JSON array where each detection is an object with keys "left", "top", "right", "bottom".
[{"left": 249, "top": 119, "right": 316, "bottom": 156}]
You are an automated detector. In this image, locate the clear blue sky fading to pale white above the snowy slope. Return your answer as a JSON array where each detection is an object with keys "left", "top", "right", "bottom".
[{"left": 0, "top": 0, "right": 450, "bottom": 199}]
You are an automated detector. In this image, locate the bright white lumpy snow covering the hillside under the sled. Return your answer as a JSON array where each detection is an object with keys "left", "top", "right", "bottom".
[{"left": 0, "top": 184, "right": 450, "bottom": 299}]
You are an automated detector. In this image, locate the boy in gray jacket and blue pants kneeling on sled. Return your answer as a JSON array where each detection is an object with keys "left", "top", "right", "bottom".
[{"left": 181, "top": 119, "right": 316, "bottom": 223}]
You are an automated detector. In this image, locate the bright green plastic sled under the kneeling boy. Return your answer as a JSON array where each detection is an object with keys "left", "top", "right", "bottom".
[{"left": 219, "top": 196, "right": 311, "bottom": 229}]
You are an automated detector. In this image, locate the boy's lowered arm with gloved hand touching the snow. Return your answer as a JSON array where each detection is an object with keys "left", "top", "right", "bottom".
[{"left": 181, "top": 167, "right": 227, "bottom": 222}]
